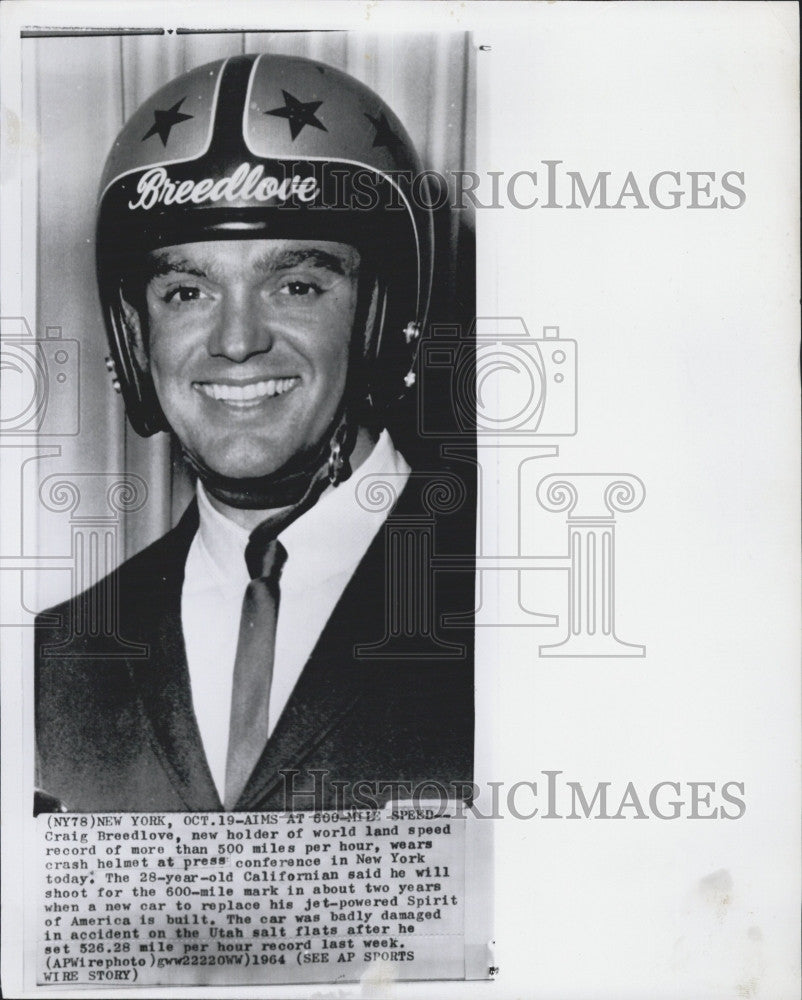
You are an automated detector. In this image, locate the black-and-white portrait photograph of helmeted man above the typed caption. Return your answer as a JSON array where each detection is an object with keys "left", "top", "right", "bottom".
[{"left": 24, "top": 32, "right": 475, "bottom": 812}]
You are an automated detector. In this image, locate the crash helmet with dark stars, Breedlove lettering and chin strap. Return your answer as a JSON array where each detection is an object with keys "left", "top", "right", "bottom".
[{"left": 96, "top": 55, "right": 432, "bottom": 507}]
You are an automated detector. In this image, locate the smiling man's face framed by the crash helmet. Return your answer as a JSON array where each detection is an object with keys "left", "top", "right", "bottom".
[{"left": 141, "top": 240, "right": 359, "bottom": 478}]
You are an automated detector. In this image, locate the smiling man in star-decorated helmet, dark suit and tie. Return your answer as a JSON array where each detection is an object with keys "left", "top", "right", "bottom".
[{"left": 36, "top": 50, "right": 473, "bottom": 811}]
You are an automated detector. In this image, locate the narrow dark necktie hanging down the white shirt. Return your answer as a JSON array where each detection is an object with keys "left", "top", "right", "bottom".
[{"left": 223, "top": 523, "right": 287, "bottom": 809}]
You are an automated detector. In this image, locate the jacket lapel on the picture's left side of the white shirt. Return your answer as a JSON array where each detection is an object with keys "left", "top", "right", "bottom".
[{"left": 124, "top": 501, "right": 222, "bottom": 811}]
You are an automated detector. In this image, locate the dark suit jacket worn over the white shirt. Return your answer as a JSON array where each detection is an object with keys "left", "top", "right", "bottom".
[{"left": 36, "top": 476, "right": 473, "bottom": 812}]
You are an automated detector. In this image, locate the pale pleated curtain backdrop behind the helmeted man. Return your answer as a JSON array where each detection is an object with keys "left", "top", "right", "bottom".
[{"left": 28, "top": 31, "right": 475, "bottom": 592}]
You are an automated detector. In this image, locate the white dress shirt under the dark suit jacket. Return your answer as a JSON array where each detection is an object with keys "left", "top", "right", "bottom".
[{"left": 181, "top": 431, "right": 410, "bottom": 798}]
